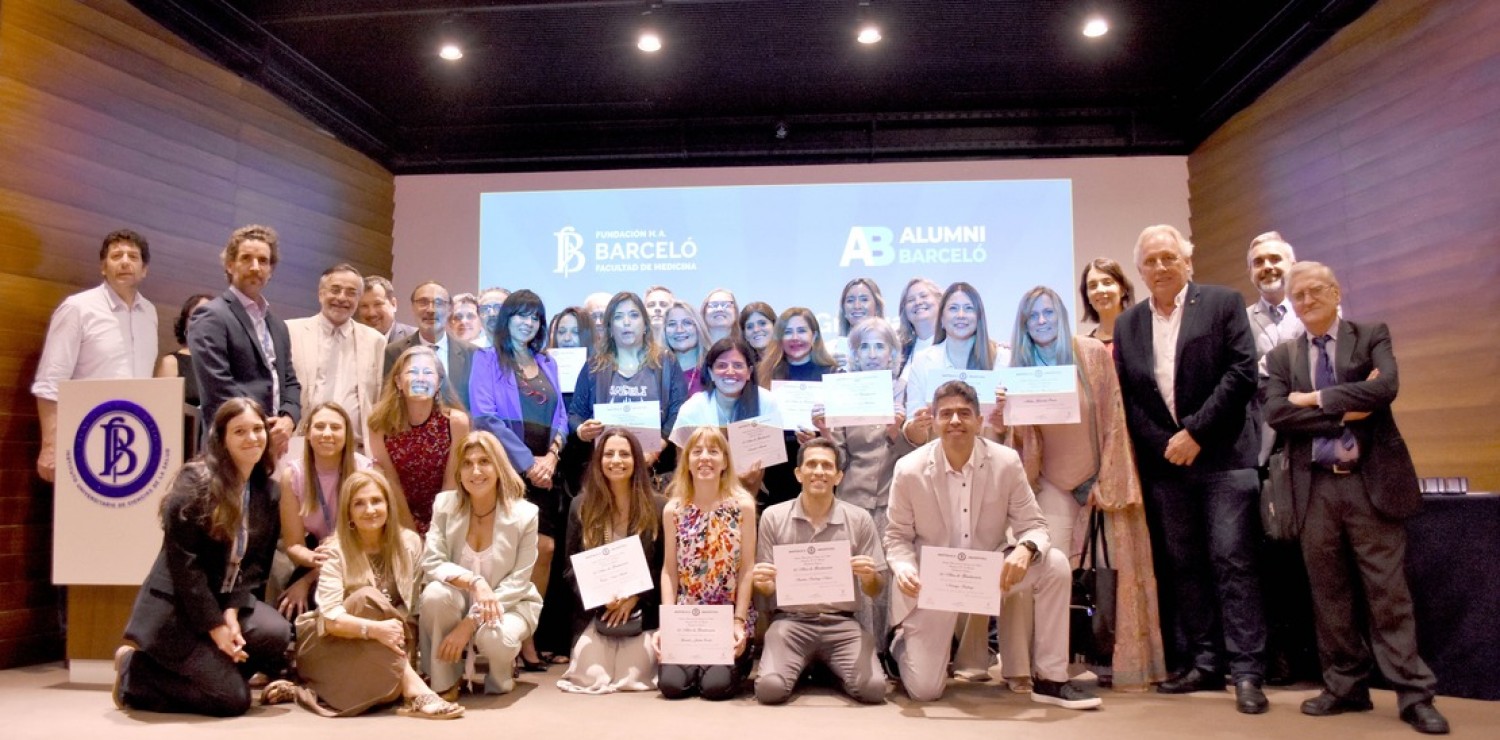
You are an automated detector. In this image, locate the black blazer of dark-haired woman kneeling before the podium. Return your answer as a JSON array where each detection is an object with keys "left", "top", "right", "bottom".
[{"left": 125, "top": 461, "right": 281, "bottom": 666}]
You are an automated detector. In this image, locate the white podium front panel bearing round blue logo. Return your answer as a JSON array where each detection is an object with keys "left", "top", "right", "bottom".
[{"left": 53, "top": 378, "right": 183, "bottom": 585}]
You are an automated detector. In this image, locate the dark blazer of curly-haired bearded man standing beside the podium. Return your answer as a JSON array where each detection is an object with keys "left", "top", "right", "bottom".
[{"left": 188, "top": 290, "right": 302, "bottom": 426}]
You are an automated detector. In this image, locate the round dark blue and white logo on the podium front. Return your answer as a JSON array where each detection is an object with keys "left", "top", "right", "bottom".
[{"left": 68, "top": 399, "right": 168, "bottom": 509}]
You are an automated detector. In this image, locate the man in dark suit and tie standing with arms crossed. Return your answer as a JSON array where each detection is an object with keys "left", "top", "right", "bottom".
[{"left": 1266, "top": 263, "right": 1448, "bottom": 734}]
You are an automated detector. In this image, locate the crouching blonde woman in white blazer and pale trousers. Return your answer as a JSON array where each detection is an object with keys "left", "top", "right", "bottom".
[{"left": 417, "top": 432, "right": 542, "bottom": 701}]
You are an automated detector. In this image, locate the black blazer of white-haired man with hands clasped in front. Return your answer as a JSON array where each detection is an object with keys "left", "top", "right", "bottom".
[{"left": 1115, "top": 282, "right": 1260, "bottom": 474}]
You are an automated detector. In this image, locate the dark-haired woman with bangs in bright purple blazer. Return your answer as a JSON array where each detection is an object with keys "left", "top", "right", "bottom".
[{"left": 470, "top": 290, "right": 567, "bottom": 669}]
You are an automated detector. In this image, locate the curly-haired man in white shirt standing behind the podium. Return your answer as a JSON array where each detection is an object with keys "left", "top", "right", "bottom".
[{"left": 32, "top": 228, "right": 156, "bottom": 482}]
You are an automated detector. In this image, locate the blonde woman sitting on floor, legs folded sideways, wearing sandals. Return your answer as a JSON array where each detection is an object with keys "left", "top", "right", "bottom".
[{"left": 261, "top": 470, "right": 464, "bottom": 719}]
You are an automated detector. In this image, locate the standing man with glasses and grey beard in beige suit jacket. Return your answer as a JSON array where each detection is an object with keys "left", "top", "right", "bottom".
[{"left": 287, "top": 263, "right": 386, "bottom": 450}]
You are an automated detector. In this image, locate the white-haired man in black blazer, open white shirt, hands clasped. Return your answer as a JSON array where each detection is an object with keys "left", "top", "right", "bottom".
[{"left": 1115, "top": 225, "right": 1268, "bottom": 714}]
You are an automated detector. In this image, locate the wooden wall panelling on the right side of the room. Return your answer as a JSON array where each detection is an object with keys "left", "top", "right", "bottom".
[{"left": 1188, "top": 0, "right": 1500, "bottom": 491}]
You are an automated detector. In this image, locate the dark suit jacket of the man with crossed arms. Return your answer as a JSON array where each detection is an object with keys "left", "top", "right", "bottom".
[{"left": 1266, "top": 320, "right": 1422, "bottom": 519}]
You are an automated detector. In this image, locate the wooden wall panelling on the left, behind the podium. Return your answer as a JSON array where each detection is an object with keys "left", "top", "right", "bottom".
[{"left": 0, "top": 0, "right": 395, "bottom": 668}]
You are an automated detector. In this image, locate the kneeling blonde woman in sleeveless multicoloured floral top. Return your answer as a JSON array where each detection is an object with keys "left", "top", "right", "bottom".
[{"left": 657, "top": 426, "right": 756, "bottom": 701}]
